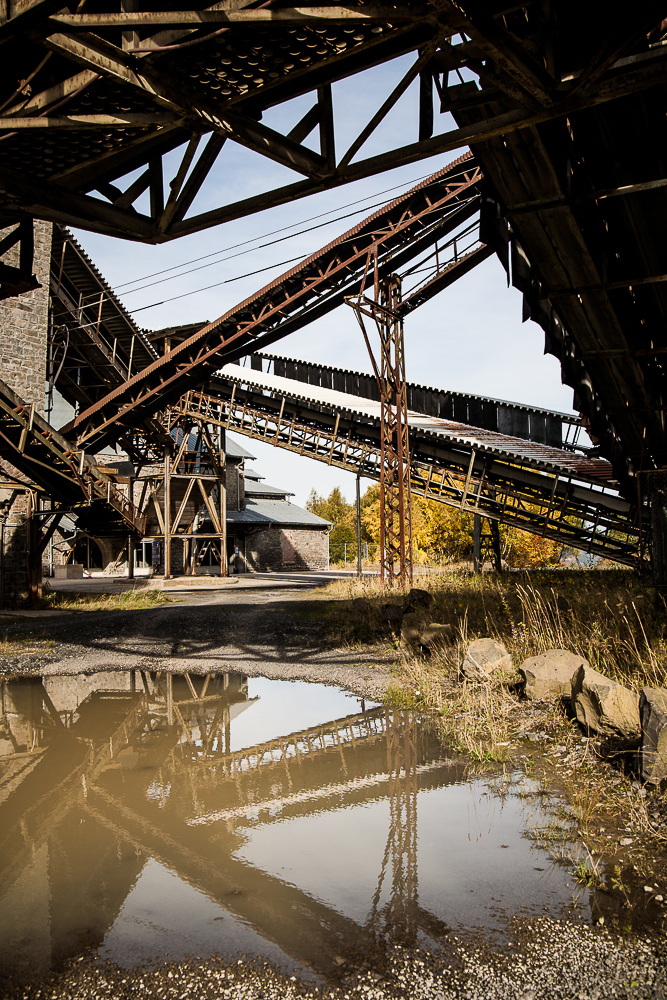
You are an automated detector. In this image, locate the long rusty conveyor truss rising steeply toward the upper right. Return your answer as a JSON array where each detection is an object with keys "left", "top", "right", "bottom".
[{"left": 63, "top": 154, "right": 481, "bottom": 450}]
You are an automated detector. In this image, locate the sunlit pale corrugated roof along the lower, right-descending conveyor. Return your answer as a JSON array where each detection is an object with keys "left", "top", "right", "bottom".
[{"left": 220, "top": 364, "right": 612, "bottom": 482}]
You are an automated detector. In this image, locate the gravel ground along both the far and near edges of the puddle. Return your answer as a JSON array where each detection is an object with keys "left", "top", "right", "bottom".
[{"left": 0, "top": 589, "right": 667, "bottom": 1000}]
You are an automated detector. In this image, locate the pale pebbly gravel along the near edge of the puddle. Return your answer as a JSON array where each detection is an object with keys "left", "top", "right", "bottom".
[{"left": 4, "top": 918, "right": 667, "bottom": 1000}]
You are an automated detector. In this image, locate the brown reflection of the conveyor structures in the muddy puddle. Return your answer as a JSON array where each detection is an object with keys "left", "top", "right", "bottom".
[{"left": 0, "top": 671, "right": 568, "bottom": 978}]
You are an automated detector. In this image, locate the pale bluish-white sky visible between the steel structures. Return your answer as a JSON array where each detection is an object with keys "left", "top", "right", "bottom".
[{"left": 70, "top": 57, "right": 572, "bottom": 505}]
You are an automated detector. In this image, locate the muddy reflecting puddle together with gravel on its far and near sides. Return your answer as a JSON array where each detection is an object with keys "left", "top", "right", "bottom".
[{"left": 0, "top": 593, "right": 667, "bottom": 1000}]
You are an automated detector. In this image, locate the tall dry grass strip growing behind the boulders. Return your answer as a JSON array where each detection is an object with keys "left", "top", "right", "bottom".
[{"left": 320, "top": 570, "right": 667, "bottom": 689}]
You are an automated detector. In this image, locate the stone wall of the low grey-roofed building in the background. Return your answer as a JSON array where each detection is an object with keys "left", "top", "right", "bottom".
[{"left": 244, "top": 526, "right": 329, "bottom": 573}]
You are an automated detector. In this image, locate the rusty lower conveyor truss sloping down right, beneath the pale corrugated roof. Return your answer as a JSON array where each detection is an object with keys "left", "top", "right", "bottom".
[{"left": 179, "top": 374, "right": 646, "bottom": 567}]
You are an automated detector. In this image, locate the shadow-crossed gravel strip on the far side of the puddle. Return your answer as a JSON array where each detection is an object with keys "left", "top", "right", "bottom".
[{"left": 0, "top": 589, "right": 393, "bottom": 700}]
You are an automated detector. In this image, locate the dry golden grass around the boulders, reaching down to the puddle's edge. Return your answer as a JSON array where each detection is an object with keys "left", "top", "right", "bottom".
[{"left": 318, "top": 570, "right": 667, "bottom": 768}]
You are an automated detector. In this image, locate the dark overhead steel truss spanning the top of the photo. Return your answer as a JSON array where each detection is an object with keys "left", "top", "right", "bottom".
[{"left": 0, "top": 0, "right": 667, "bottom": 243}]
